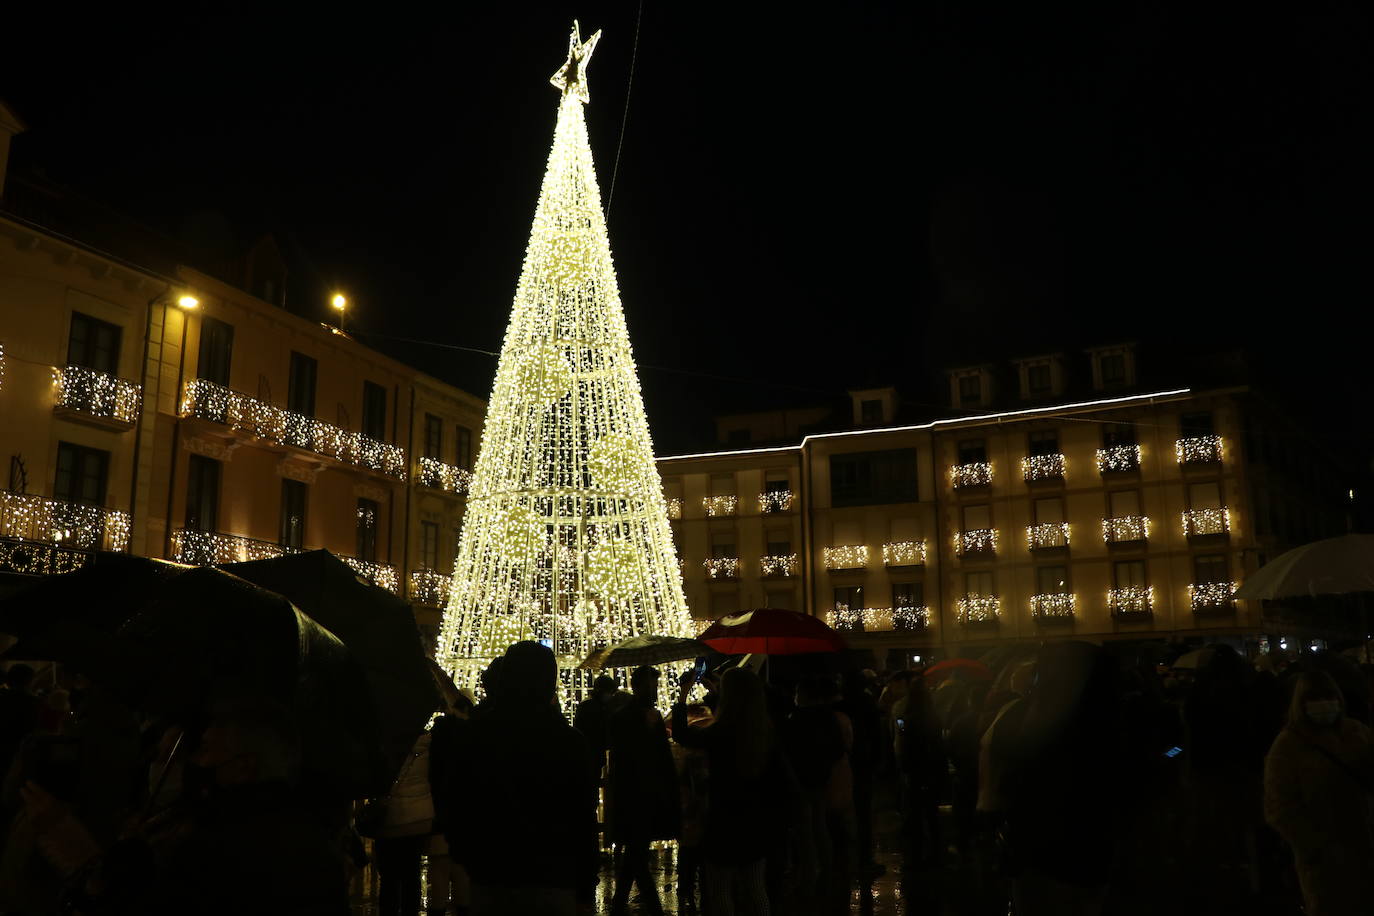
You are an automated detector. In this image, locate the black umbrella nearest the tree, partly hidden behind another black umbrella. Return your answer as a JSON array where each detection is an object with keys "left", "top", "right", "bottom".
[{"left": 224, "top": 551, "right": 440, "bottom": 772}]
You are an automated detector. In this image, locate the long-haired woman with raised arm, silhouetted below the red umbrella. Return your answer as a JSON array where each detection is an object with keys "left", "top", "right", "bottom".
[{"left": 673, "top": 667, "right": 798, "bottom": 916}]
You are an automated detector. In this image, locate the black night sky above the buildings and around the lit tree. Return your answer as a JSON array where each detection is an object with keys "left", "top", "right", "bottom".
[{"left": 0, "top": 0, "right": 1374, "bottom": 452}]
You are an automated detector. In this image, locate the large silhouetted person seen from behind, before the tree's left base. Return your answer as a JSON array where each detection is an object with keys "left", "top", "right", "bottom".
[{"left": 445, "top": 640, "right": 596, "bottom": 916}]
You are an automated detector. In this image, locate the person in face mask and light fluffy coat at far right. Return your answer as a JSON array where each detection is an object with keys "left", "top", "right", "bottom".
[{"left": 1264, "top": 672, "right": 1374, "bottom": 916}]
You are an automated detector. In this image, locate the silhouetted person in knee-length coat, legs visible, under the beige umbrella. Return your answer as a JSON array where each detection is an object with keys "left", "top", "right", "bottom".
[{"left": 606, "top": 666, "right": 680, "bottom": 916}]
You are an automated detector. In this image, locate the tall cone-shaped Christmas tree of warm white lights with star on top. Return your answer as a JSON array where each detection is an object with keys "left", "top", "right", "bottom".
[{"left": 437, "top": 22, "right": 691, "bottom": 696}]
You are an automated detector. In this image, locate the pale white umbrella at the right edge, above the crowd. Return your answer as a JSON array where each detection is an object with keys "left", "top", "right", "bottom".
[{"left": 1235, "top": 534, "right": 1374, "bottom": 600}]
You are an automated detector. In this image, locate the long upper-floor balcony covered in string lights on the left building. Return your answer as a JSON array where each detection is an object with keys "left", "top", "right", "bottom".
[{"left": 181, "top": 379, "right": 405, "bottom": 481}]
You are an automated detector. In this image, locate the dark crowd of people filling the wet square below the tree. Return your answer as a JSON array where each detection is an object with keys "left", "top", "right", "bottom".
[{"left": 0, "top": 641, "right": 1374, "bottom": 916}]
